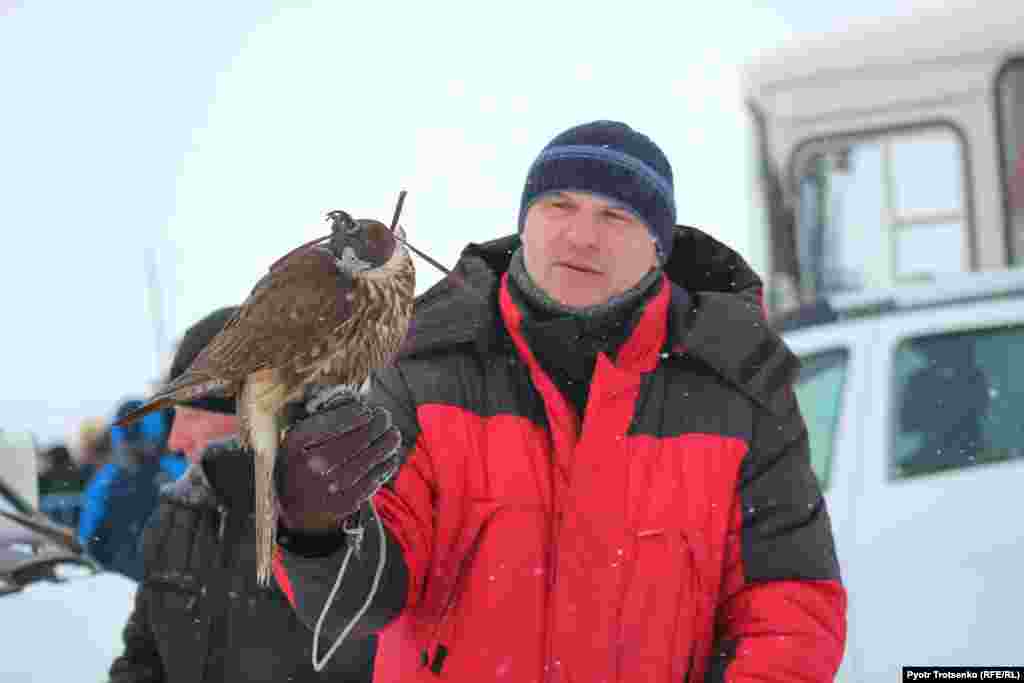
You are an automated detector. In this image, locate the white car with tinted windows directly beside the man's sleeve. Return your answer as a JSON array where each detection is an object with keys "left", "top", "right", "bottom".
[{"left": 780, "top": 269, "right": 1024, "bottom": 681}]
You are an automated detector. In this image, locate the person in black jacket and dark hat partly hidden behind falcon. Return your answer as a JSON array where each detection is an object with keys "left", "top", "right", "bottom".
[{"left": 110, "top": 307, "right": 375, "bottom": 683}]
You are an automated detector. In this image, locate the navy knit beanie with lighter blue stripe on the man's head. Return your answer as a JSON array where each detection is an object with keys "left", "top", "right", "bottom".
[{"left": 519, "top": 121, "right": 676, "bottom": 263}]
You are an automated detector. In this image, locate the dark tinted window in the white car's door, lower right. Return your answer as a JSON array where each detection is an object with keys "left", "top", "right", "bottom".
[{"left": 890, "top": 326, "right": 1024, "bottom": 479}]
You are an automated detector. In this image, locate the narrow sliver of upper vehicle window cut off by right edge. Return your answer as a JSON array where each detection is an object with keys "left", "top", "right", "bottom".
[{"left": 995, "top": 57, "right": 1024, "bottom": 265}]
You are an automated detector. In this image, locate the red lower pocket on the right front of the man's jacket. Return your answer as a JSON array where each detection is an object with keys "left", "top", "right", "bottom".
[{"left": 616, "top": 527, "right": 701, "bottom": 683}]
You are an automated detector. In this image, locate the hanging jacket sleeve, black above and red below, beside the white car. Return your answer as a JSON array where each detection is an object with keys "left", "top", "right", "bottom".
[{"left": 709, "top": 401, "right": 847, "bottom": 683}]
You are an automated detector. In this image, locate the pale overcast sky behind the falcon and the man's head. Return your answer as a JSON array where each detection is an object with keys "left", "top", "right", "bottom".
[{"left": 0, "top": 0, "right": 913, "bottom": 442}]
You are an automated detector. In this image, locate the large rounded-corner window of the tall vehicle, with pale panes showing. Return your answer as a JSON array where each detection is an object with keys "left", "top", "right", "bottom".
[{"left": 797, "top": 126, "right": 972, "bottom": 296}]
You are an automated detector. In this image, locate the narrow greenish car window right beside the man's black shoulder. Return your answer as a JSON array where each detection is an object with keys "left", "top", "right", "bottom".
[{"left": 796, "top": 349, "right": 849, "bottom": 488}]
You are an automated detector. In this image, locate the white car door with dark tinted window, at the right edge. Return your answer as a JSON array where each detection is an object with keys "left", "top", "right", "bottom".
[{"left": 844, "top": 299, "right": 1024, "bottom": 680}]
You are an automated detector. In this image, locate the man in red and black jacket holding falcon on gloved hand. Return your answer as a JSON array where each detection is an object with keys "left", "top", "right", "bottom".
[{"left": 275, "top": 121, "right": 846, "bottom": 682}]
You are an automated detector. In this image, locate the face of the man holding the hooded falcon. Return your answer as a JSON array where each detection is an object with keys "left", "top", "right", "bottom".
[{"left": 522, "top": 191, "right": 657, "bottom": 308}]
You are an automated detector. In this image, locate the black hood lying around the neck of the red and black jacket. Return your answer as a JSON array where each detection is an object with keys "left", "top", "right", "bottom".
[{"left": 399, "top": 225, "right": 799, "bottom": 412}]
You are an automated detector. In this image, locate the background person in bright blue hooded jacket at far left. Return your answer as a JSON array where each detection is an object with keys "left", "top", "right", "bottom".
[{"left": 78, "top": 398, "right": 186, "bottom": 581}]
